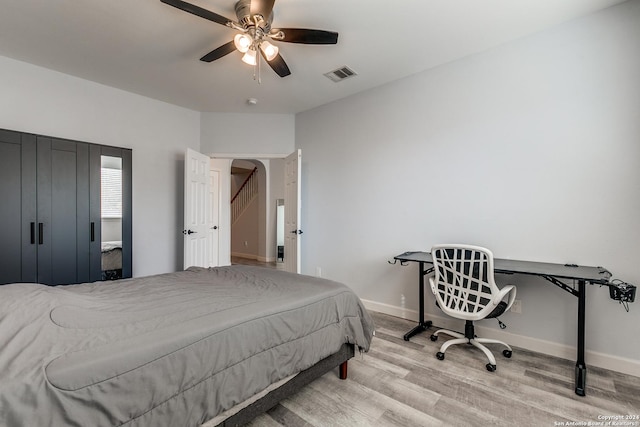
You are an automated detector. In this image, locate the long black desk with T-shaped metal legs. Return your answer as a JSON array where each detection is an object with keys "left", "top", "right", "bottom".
[{"left": 394, "top": 252, "right": 611, "bottom": 396}]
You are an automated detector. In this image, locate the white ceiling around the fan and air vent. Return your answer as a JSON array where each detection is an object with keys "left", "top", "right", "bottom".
[{"left": 0, "top": 0, "right": 623, "bottom": 113}]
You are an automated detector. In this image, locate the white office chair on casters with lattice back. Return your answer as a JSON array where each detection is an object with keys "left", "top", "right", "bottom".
[{"left": 429, "top": 245, "right": 516, "bottom": 372}]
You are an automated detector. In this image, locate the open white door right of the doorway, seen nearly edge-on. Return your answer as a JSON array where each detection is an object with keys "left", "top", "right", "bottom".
[{"left": 284, "top": 150, "right": 302, "bottom": 273}]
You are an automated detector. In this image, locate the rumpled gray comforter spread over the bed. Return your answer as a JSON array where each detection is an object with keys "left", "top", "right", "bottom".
[{"left": 0, "top": 266, "right": 373, "bottom": 427}]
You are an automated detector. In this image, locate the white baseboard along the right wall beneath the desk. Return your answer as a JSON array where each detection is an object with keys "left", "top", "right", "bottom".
[{"left": 362, "top": 300, "right": 640, "bottom": 377}]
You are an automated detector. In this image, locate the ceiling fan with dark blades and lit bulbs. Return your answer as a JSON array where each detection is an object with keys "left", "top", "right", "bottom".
[{"left": 160, "top": 0, "right": 338, "bottom": 77}]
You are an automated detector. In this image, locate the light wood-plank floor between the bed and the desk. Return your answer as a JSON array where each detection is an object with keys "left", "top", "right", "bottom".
[{"left": 245, "top": 313, "right": 640, "bottom": 427}]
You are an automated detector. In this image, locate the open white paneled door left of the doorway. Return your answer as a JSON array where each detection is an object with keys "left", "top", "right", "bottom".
[{"left": 182, "top": 149, "right": 210, "bottom": 268}]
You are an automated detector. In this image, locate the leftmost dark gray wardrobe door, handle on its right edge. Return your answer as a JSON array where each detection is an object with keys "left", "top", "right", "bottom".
[{"left": 0, "top": 130, "right": 36, "bottom": 284}]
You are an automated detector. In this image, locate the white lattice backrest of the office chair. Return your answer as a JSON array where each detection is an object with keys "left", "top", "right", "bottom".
[{"left": 432, "top": 248, "right": 496, "bottom": 313}]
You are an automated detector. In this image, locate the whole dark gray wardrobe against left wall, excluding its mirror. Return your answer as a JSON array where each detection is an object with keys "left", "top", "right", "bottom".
[{"left": 0, "top": 129, "right": 132, "bottom": 285}]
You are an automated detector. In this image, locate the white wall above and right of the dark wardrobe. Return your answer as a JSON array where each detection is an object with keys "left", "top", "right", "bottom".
[{"left": 0, "top": 57, "right": 200, "bottom": 276}]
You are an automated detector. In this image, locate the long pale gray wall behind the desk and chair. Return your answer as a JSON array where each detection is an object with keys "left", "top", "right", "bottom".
[{"left": 296, "top": 1, "right": 640, "bottom": 375}]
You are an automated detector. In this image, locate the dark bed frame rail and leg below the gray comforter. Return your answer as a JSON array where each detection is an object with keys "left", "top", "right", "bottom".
[{"left": 217, "top": 344, "right": 355, "bottom": 427}]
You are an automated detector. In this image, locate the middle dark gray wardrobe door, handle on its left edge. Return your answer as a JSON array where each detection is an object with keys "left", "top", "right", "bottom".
[{"left": 37, "top": 137, "right": 90, "bottom": 285}]
